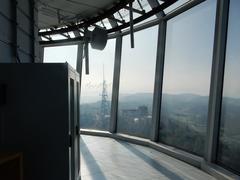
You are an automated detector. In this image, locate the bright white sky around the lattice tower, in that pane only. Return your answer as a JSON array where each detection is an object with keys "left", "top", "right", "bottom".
[{"left": 81, "top": 40, "right": 115, "bottom": 103}]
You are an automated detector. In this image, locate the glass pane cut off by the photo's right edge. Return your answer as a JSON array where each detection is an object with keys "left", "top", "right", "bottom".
[{"left": 218, "top": 0, "right": 240, "bottom": 173}]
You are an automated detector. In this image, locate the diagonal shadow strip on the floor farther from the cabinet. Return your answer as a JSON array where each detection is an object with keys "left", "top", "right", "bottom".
[{"left": 117, "top": 141, "right": 184, "bottom": 180}]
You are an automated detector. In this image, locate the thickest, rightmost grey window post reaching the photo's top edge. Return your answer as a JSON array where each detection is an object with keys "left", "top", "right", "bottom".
[{"left": 204, "top": 0, "right": 229, "bottom": 163}]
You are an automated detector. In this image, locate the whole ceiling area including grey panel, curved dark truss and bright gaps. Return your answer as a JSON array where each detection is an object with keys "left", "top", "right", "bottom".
[{"left": 35, "top": 0, "right": 178, "bottom": 44}]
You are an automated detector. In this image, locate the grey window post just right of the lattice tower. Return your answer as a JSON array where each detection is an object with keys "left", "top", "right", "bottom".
[{"left": 109, "top": 36, "right": 122, "bottom": 133}]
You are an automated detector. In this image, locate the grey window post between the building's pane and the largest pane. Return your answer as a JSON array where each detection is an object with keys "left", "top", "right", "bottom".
[{"left": 151, "top": 20, "right": 167, "bottom": 142}]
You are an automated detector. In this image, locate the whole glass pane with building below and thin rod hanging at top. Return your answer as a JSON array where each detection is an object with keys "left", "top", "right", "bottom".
[{"left": 117, "top": 27, "right": 158, "bottom": 138}]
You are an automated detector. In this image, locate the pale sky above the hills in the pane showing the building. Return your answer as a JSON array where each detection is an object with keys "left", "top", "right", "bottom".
[{"left": 120, "top": 26, "right": 158, "bottom": 94}]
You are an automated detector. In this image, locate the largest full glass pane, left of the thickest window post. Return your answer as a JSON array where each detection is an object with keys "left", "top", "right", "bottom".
[{"left": 159, "top": 0, "right": 216, "bottom": 155}]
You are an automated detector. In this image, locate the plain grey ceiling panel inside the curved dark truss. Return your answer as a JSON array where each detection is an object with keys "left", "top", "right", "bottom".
[{"left": 37, "top": 0, "right": 120, "bottom": 29}]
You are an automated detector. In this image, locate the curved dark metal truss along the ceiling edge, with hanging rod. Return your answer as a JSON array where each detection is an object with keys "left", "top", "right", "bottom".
[{"left": 39, "top": 0, "right": 177, "bottom": 48}]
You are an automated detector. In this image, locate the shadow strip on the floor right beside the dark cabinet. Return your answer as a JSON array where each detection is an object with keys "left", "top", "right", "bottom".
[{"left": 80, "top": 138, "right": 107, "bottom": 180}]
